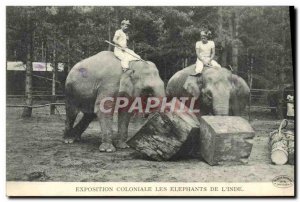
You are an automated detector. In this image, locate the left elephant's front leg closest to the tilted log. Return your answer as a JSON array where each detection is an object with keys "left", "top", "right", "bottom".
[{"left": 116, "top": 111, "right": 133, "bottom": 149}]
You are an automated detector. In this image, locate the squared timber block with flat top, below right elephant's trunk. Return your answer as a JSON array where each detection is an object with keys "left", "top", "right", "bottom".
[{"left": 200, "top": 116, "right": 255, "bottom": 165}]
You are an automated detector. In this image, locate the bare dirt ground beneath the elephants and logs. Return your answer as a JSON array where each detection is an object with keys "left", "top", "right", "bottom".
[{"left": 6, "top": 100, "right": 294, "bottom": 182}]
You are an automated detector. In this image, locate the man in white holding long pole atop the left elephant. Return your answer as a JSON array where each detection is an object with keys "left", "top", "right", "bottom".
[{"left": 113, "top": 20, "right": 141, "bottom": 72}]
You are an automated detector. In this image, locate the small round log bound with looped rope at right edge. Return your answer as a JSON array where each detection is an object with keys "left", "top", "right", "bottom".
[{"left": 269, "top": 120, "right": 294, "bottom": 165}]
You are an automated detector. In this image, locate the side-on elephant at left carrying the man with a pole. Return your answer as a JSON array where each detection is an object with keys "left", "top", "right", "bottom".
[{"left": 63, "top": 51, "right": 165, "bottom": 152}]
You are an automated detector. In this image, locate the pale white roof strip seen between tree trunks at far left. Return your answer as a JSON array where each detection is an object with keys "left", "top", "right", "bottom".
[{"left": 6, "top": 61, "right": 64, "bottom": 72}]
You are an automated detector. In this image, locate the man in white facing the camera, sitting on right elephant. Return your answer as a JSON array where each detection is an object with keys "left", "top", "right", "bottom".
[{"left": 192, "top": 31, "right": 221, "bottom": 76}]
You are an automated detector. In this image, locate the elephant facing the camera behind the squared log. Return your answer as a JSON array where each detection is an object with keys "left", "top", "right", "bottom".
[{"left": 166, "top": 65, "right": 250, "bottom": 115}]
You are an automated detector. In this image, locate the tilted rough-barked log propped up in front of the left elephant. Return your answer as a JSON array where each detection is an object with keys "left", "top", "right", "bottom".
[{"left": 127, "top": 109, "right": 199, "bottom": 161}]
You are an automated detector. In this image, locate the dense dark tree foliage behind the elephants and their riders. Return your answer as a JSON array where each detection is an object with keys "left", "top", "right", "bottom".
[{"left": 7, "top": 6, "right": 293, "bottom": 88}]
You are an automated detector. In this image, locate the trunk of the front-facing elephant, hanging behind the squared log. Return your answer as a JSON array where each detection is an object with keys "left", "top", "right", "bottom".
[{"left": 213, "top": 93, "right": 229, "bottom": 116}]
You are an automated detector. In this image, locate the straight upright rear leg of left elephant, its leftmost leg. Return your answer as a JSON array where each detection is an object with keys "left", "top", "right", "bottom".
[{"left": 63, "top": 100, "right": 79, "bottom": 143}]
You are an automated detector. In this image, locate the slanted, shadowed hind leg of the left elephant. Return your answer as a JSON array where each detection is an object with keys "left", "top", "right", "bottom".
[{"left": 72, "top": 113, "right": 96, "bottom": 141}]
